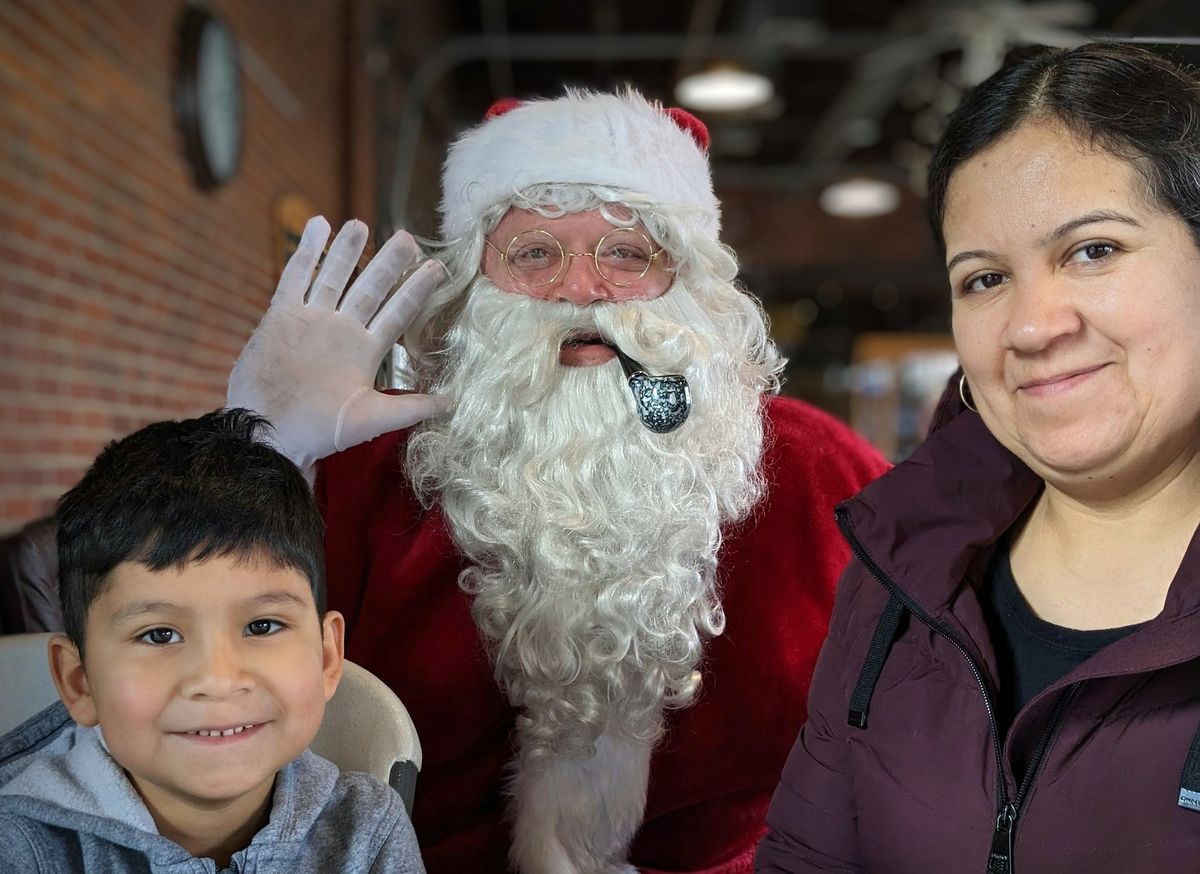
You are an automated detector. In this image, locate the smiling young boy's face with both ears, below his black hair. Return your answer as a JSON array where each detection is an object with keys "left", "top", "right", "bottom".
[{"left": 52, "top": 557, "right": 343, "bottom": 816}]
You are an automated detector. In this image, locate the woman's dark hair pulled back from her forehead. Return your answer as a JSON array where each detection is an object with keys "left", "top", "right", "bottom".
[{"left": 928, "top": 42, "right": 1200, "bottom": 251}]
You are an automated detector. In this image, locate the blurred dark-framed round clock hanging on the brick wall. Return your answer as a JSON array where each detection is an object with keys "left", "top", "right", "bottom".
[{"left": 175, "top": 5, "right": 242, "bottom": 191}]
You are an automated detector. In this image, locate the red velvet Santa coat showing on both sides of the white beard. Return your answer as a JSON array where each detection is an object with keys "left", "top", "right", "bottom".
[{"left": 317, "top": 397, "right": 886, "bottom": 874}]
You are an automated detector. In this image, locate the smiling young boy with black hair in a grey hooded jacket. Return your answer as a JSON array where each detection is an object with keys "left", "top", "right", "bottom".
[{"left": 0, "top": 409, "right": 424, "bottom": 874}]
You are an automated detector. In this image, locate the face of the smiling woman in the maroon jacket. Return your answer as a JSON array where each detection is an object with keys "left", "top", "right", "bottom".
[{"left": 943, "top": 122, "right": 1200, "bottom": 489}]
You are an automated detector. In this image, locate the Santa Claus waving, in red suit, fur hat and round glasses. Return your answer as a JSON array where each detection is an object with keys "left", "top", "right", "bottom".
[{"left": 229, "top": 91, "right": 884, "bottom": 874}]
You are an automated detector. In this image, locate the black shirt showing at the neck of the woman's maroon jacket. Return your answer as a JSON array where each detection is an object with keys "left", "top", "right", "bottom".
[{"left": 980, "top": 544, "right": 1139, "bottom": 735}]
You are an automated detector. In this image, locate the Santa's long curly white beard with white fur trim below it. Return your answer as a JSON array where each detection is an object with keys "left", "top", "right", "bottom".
[{"left": 408, "top": 277, "right": 769, "bottom": 874}]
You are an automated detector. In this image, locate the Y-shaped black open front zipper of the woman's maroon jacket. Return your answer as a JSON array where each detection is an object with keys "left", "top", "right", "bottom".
[{"left": 835, "top": 507, "right": 1079, "bottom": 874}]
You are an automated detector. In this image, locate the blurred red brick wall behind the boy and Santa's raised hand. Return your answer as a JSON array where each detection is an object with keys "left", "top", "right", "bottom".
[{"left": 0, "top": 0, "right": 374, "bottom": 532}]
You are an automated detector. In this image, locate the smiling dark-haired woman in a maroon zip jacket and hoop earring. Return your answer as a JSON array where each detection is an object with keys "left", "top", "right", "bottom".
[{"left": 756, "top": 44, "right": 1200, "bottom": 874}]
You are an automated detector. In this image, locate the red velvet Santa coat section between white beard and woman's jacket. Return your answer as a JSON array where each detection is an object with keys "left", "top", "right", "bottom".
[{"left": 632, "top": 399, "right": 888, "bottom": 874}]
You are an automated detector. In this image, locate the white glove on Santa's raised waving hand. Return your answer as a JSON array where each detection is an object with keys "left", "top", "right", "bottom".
[{"left": 227, "top": 216, "right": 446, "bottom": 481}]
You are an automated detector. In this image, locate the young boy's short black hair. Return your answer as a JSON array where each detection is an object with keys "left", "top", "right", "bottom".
[{"left": 56, "top": 409, "right": 325, "bottom": 653}]
